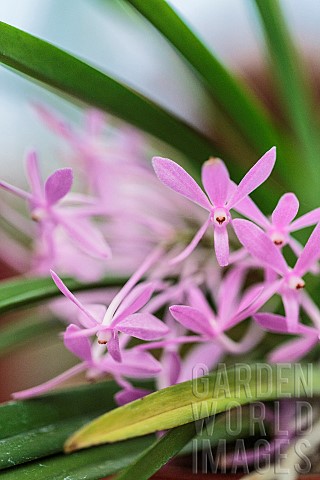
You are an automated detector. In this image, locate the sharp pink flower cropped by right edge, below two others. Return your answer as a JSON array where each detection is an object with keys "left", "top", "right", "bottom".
[{"left": 233, "top": 219, "right": 320, "bottom": 329}]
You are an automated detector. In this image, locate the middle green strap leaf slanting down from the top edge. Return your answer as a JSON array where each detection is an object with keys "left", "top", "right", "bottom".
[{"left": 126, "top": 0, "right": 282, "bottom": 153}]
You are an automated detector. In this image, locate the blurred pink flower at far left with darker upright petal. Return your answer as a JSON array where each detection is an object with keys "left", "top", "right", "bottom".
[{"left": 0, "top": 152, "right": 111, "bottom": 258}]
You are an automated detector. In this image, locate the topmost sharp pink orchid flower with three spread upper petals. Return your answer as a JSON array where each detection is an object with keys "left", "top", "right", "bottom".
[{"left": 153, "top": 147, "right": 276, "bottom": 266}]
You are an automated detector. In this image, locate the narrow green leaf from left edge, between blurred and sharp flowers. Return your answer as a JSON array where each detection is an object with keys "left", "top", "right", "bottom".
[{"left": 0, "top": 277, "right": 127, "bottom": 313}]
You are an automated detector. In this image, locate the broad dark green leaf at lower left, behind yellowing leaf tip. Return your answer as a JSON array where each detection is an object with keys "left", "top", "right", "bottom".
[{"left": 0, "top": 382, "right": 119, "bottom": 468}]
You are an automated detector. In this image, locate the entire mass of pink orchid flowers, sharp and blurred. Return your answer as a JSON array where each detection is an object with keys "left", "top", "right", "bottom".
[{"left": 0, "top": 106, "right": 320, "bottom": 404}]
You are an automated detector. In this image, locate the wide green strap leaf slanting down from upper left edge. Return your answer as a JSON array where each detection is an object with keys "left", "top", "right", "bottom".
[{"left": 0, "top": 22, "right": 218, "bottom": 173}]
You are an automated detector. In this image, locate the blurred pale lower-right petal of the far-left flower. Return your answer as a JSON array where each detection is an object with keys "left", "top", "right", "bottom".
[{"left": 56, "top": 214, "right": 111, "bottom": 259}]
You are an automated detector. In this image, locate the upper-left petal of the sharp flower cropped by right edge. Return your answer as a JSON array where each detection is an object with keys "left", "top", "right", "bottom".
[{"left": 232, "top": 218, "right": 288, "bottom": 275}]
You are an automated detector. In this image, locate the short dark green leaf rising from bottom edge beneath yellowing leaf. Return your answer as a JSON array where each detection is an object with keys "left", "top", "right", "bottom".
[{"left": 116, "top": 423, "right": 196, "bottom": 480}]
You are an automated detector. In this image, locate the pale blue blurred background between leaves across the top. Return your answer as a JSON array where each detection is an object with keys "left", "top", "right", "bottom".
[{"left": 0, "top": 0, "right": 320, "bottom": 180}]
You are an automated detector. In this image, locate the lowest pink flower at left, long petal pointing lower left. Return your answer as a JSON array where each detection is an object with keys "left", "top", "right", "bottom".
[{"left": 13, "top": 325, "right": 161, "bottom": 404}]
